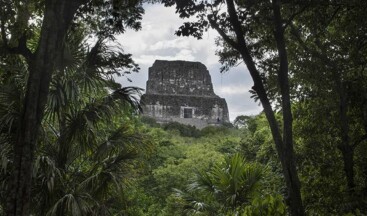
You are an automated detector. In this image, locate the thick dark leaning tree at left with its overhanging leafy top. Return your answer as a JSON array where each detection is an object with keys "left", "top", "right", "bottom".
[{"left": 0, "top": 0, "right": 143, "bottom": 215}]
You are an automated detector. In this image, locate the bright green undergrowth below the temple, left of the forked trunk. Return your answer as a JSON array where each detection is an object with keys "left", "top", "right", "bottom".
[{"left": 119, "top": 118, "right": 285, "bottom": 215}]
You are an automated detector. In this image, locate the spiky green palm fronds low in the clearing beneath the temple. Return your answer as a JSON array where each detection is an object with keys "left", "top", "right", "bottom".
[{"left": 182, "top": 154, "right": 264, "bottom": 211}]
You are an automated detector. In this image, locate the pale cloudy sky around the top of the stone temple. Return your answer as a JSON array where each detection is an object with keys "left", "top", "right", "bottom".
[{"left": 117, "top": 4, "right": 262, "bottom": 121}]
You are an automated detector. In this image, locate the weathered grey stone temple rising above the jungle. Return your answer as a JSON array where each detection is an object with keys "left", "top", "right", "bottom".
[{"left": 141, "top": 60, "right": 229, "bottom": 128}]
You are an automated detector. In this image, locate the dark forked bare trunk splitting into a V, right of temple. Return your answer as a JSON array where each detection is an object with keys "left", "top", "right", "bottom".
[{"left": 223, "top": 0, "right": 305, "bottom": 216}]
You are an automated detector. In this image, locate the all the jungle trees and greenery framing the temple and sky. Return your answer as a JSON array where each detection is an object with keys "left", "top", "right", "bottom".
[{"left": 0, "top": 0, "right": 367, "bottom": 216}]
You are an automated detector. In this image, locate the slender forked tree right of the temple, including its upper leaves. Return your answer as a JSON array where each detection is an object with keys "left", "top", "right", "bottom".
[{"left": 166, "top": 0, "right": 305, "bottom": 215}]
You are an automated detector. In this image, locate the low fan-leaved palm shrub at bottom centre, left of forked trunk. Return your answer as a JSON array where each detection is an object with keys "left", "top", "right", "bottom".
[{"left": 175, "top": 154, "right": 268, "bottom": 215}]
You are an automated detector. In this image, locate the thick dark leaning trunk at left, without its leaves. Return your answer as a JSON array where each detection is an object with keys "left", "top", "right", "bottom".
[{"left": 6, "top": 0, "right": 81, "bottom": 216}]
